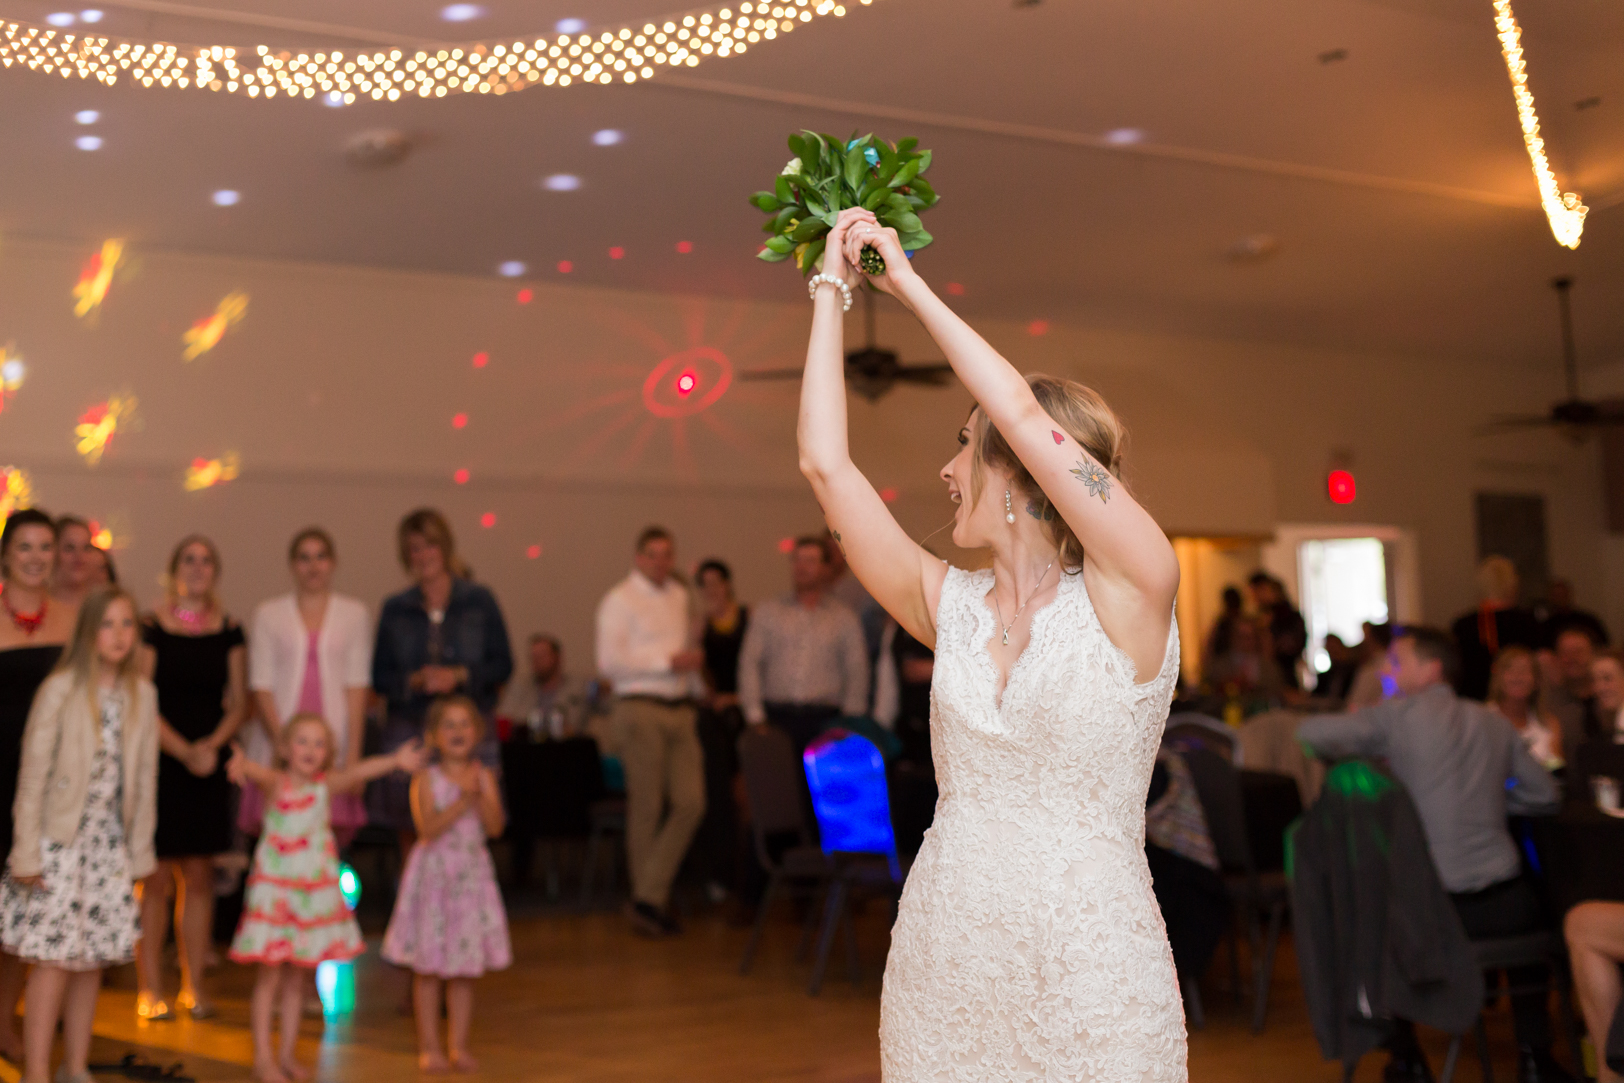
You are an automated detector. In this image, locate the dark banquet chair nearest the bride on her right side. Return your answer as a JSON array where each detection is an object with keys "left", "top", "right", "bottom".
[{"left": 1181, "top": 744, "right": 1289, "bottom": 1034}]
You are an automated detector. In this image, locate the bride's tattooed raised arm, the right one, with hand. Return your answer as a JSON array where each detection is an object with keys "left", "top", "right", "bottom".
[{"left": 830, "top": 209, "right": 1179, "bottom": 680}]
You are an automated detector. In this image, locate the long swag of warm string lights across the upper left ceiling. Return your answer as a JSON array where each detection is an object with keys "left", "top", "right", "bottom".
[{"left": 0, "top": 0, "right": 874, "bottom": 102}]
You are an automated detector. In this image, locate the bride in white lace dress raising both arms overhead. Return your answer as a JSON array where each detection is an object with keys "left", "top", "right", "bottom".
[{"left": 799, "top": 209, "right": 1187, "bottom": 1083}]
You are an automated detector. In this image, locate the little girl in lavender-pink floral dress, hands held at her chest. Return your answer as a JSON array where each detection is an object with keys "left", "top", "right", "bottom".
[{"left": 383, "top": 697, "right": 513, "bottom": 1072}]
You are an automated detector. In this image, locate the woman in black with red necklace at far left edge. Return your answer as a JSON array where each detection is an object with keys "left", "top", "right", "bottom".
[{"left": 0, "top": 508, "right": 80, "bottom": 1062}]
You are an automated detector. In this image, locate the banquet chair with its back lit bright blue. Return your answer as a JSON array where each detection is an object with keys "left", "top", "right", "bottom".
[{"left": 802, "top": 729, "right": 903, "bottom": 997}]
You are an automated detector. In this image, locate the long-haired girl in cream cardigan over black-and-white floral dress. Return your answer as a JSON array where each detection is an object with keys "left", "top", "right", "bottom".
[{"left": 0, "top": 589, "right": 158, "bottom": 1083}]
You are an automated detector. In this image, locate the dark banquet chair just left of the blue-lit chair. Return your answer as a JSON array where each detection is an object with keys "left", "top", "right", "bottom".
[{"left": 739, "top": 726, "right": 835, "bottom": 974}]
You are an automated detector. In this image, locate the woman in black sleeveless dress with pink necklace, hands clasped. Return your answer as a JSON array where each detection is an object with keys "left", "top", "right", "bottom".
[{"left": 135, "top": 534, "right": 248, "bottom": 1020}]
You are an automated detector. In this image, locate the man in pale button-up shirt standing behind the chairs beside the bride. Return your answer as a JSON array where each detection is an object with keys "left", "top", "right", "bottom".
[{"left": 739, "top": 537, "right": 869, "bottom": 753}]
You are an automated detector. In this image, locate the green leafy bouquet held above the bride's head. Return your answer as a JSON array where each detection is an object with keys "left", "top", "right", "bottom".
[{"left": 750, "top": 132, "right": 939, "bottom": 274}]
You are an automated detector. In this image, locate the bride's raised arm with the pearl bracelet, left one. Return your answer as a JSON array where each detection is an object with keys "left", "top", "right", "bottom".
[{"left": 797, "top": 211, "right": 947, "bottom": 645}]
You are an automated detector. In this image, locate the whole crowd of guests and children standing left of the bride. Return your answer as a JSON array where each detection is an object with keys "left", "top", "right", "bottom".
[{"left": 0, "top": 508, "right": 932, "bottom": 1083}]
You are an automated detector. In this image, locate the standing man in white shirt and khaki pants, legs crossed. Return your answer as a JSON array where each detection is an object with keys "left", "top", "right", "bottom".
[{"left": 598, "top": 526, "right": 705, "bottom": 937}]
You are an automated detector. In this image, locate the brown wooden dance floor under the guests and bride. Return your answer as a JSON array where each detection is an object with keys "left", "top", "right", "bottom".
[{"left": 38, "top": 906, "right": 1533, "bottom": 1083}]
